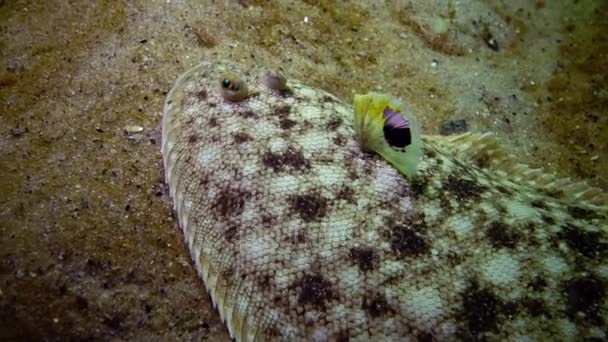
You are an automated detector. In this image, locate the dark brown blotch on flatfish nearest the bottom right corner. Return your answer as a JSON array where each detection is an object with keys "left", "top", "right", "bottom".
[{"left": 565, "top": 276, "right": 605, "bottom": 322}]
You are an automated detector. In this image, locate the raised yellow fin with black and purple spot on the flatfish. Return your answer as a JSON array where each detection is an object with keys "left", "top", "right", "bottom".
[{"left": 355, "top": 93, "right": 421, "bottom": 176}]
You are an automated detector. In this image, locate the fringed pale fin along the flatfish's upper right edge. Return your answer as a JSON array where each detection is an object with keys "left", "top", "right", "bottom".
[{"left": 423, "top": 133, "right": 608, "bottom": 210}]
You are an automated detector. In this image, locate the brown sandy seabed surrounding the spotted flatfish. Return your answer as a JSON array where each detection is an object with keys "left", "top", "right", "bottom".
[{"left": 0, "top": 0, "right": 608, "bottom": 340}]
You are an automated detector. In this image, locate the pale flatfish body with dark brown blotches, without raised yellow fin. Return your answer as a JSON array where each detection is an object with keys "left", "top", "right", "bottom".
[{"left": 162, "top": 63, "right": 608, "bottom": 341}]
